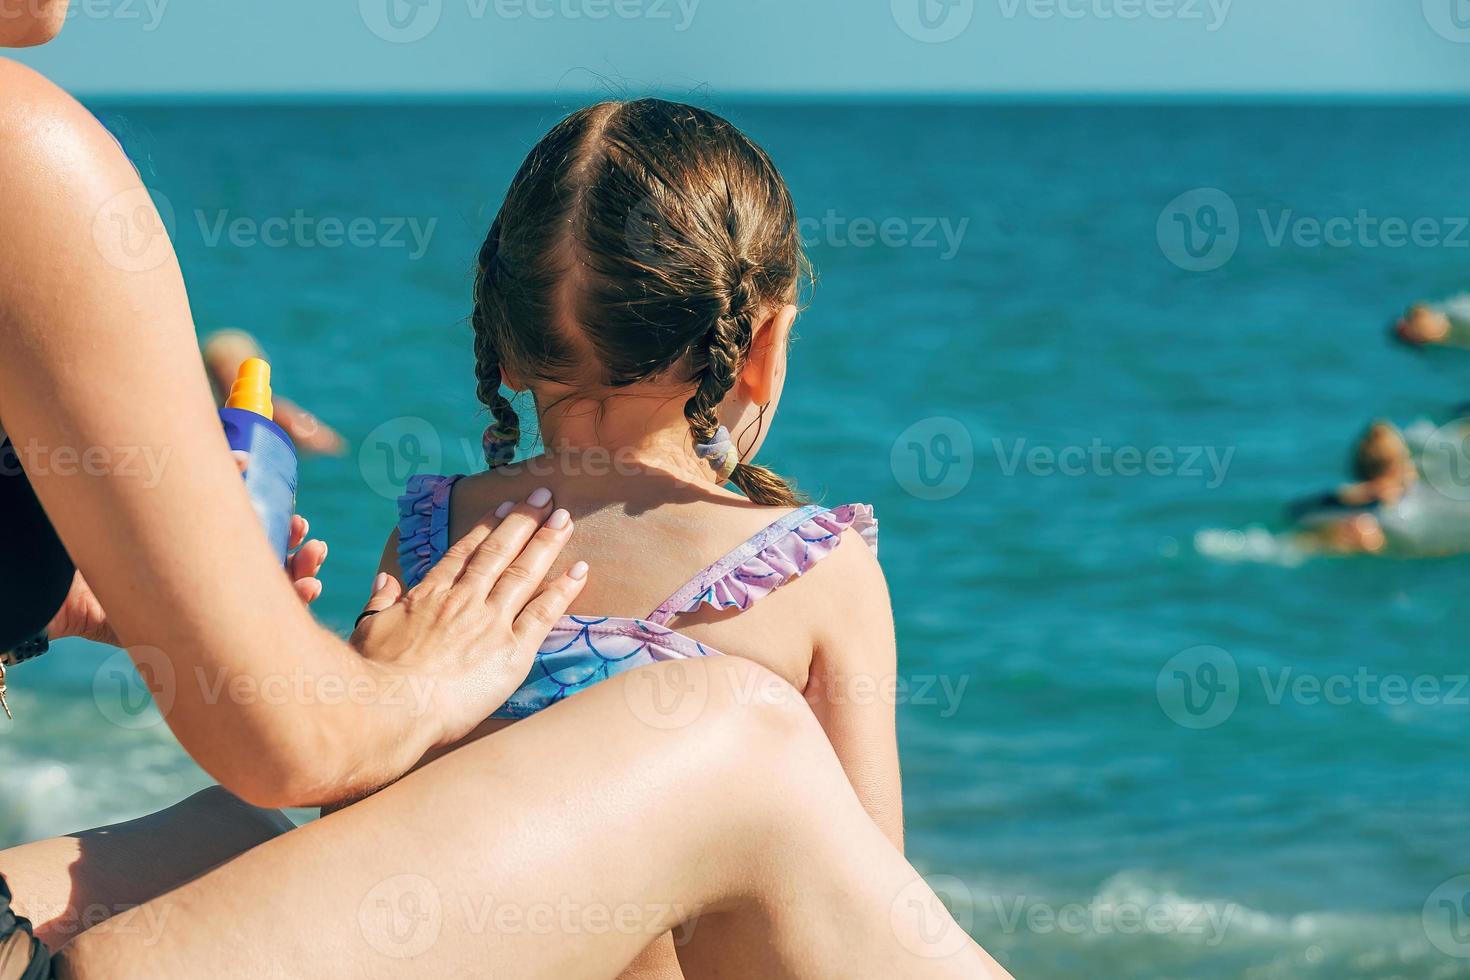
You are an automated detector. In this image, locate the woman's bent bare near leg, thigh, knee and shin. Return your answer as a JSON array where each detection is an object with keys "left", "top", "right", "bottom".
[{"left": 59, "top": 658, "right": 1007, "bottom": 980}]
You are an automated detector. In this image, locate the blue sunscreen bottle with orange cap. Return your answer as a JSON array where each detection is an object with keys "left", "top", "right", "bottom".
[{"left": 219, "top": 357, "right": 297, "bottom": 564}]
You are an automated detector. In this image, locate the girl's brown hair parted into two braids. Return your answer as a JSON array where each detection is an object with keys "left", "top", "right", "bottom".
[{"left": 470, "top": 98, "right": 809, "bottom": 505}]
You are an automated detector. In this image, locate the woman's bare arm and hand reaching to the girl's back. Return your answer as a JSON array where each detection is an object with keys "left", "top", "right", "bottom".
[{"left": 0, "top": 59, "right": 581, "bottom": 807}]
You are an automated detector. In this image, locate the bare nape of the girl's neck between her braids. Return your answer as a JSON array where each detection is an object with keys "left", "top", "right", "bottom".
[{"left": 538, "top": 391, "right": 711, "bottom": 482}]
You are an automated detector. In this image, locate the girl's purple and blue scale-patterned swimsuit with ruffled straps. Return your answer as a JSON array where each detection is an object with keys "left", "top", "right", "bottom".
[{"left": 398, "top": 475, "right": 878, "bottom": 718}]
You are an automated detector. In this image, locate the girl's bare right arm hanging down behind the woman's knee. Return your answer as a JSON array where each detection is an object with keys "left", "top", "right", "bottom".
[{"left": 803, "top": 532, "right": 904, "bottom": 851}]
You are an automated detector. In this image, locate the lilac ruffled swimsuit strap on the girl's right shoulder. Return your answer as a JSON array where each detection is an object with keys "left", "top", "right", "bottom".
[{"left": 645, "top": 504, "right": 878, "bottom": 626}]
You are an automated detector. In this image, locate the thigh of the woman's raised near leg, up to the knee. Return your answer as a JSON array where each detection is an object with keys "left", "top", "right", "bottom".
[{"left": 51, "top": 658, "right": 823, "bottom": 980}]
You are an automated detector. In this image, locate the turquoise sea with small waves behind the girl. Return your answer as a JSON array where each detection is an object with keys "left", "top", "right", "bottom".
[{"left": 0, "top": 97, "right": 1470, "bottom": 980}]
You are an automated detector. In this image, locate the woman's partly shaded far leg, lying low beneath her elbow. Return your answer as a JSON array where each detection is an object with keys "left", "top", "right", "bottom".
[{"left": 0, "top": 786, "right": 291, "bottom": 949}]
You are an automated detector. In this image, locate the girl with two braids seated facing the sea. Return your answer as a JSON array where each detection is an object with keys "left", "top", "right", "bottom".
[{"left": 373, "top": 100, "right": 903, "bottom": 976}]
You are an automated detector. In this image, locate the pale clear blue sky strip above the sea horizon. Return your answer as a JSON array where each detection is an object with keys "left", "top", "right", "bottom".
[{"left": 18, "top": 0, "right": 1470, "bottom": 96}]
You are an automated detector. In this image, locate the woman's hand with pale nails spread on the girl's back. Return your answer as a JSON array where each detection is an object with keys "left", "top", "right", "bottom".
[{"left": 351, "top": 491, "right": 587, "bottom": 745}]
